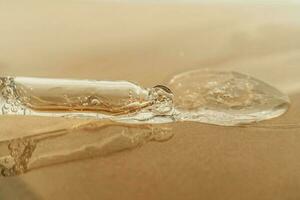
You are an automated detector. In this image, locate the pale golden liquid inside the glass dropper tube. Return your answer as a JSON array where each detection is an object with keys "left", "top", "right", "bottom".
[{"left": 14, "top": 77, "right": 151, "bottom": 114}]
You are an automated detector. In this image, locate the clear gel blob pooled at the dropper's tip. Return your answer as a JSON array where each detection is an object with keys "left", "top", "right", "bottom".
[{"left": 168, "top": 70, "right": 289, "bottom": 126}]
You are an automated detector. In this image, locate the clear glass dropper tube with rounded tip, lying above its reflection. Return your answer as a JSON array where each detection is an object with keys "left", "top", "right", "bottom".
[{"left": 0, "top": 77, "right": 173, "bottom": 120}]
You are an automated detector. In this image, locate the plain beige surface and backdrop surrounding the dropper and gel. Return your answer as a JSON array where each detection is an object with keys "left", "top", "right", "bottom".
[{"left": 0, "top": 1, "right": 300, "bottom": 200}]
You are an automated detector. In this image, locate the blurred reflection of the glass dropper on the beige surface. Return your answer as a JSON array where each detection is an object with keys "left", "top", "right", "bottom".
[{"left": 0, "top": 120, "right": 173, "bottom": 177}]
